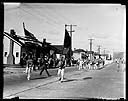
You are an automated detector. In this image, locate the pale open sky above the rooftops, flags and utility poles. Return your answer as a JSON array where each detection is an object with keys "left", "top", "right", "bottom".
[{"left": 4, "top": 3, "right": 126, "bottom": 52}]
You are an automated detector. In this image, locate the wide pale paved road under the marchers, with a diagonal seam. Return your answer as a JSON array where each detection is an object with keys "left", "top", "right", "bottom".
[{"left": 4, "top": 64, "right": 125, "bottom": 99}]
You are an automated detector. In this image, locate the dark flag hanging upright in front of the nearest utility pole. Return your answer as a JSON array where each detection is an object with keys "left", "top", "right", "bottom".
[{"left": 64, "top": 29, "right": 71, "bottom": 48}]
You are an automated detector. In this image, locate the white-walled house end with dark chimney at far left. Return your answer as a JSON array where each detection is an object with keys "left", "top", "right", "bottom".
[{"left": 3, "top": 30, "right": 24, "bottom": 64}]
